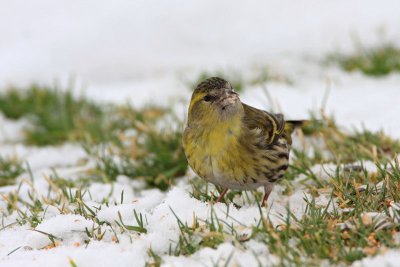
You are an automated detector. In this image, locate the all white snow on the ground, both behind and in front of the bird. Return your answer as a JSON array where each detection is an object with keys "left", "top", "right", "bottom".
[{"left": 0, "top": 0, "right": 400, "bottom": 267}]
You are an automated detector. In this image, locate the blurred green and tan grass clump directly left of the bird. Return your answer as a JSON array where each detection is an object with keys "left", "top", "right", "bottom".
[{"left": 85, "top": 127, "right": 188, "bottom": 190}]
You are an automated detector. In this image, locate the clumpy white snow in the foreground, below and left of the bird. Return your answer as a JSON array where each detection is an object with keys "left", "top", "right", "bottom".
[{"left": 0, "top": 173, "right": 318, "bottom": 266}]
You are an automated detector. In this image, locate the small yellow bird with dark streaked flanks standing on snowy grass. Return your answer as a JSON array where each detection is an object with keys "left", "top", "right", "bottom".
[{"left": 183, "top": 77, "right": 301, "bottom": 207}]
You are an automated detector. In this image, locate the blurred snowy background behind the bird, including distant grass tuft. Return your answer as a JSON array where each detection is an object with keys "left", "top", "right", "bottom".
[{"left": 0, "top": 0, "right": 400, "bottom": 136}]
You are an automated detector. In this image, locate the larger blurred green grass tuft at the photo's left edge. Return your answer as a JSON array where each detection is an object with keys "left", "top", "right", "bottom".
[{"left": 0, "top": 85, "right": 104, "bottom": 146}]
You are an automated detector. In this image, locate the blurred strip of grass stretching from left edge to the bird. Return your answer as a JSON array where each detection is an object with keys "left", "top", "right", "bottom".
[{"left": 0, "top": 85, "right": 187, "bottom": 190}]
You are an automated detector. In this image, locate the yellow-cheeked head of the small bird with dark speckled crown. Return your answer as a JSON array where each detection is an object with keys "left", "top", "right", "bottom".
[{"left": 188, "top": 77, "right": 243, "bottom": 123}]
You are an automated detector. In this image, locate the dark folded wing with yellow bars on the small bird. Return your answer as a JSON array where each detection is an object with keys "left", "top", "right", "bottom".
[{"left": 243, "top": 104, "right": 285, "bottom": 145}]
